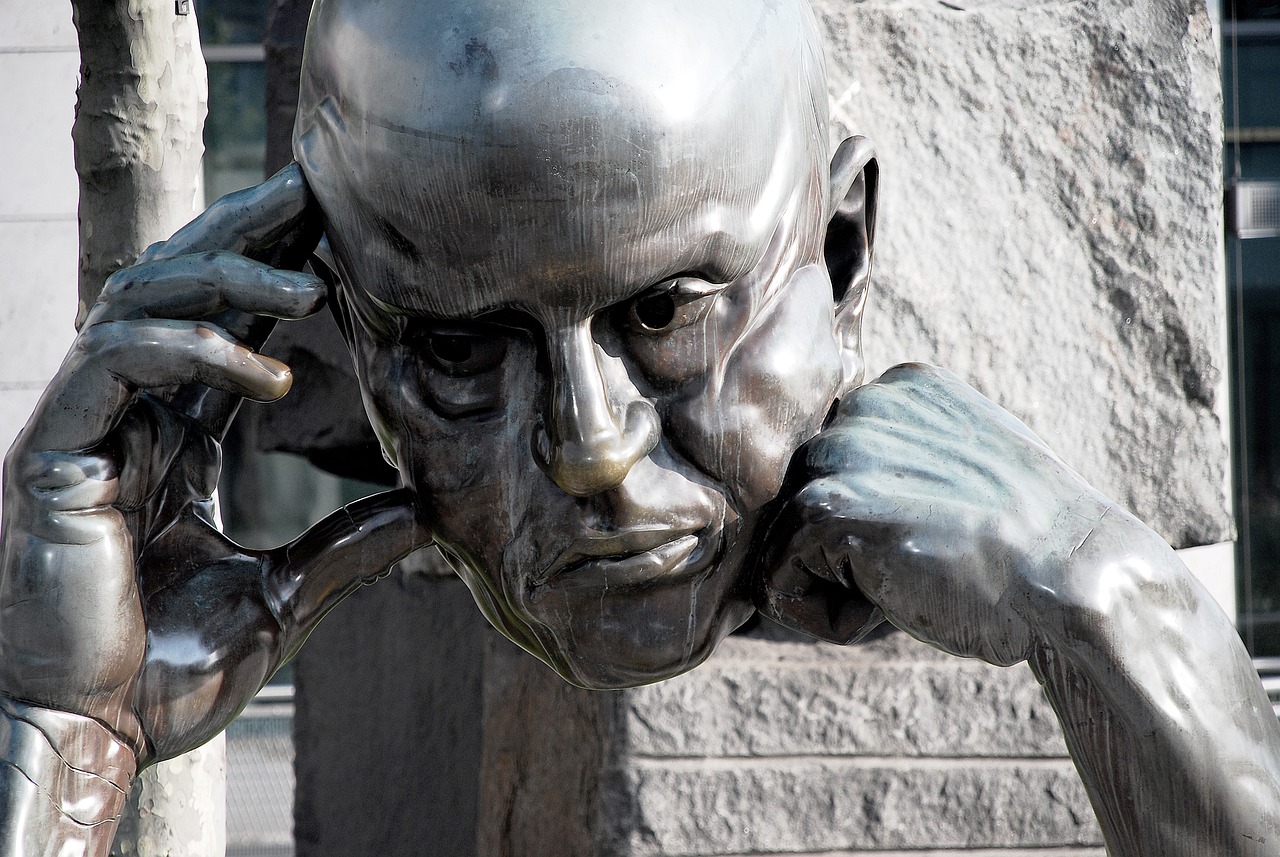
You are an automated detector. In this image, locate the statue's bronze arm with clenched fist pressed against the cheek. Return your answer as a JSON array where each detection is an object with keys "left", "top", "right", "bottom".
[{"left": 756, "top": 366, "right": 1280, "bottom": 857}]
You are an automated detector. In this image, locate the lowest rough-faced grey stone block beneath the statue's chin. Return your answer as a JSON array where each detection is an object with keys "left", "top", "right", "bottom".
[{"left": 605, "top": 757, "right": 1101, "bottom": 857}]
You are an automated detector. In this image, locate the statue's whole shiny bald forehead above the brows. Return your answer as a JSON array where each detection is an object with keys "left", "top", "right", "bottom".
[{"left": 296, "top": 0, "right": 826, "bottom": 317}]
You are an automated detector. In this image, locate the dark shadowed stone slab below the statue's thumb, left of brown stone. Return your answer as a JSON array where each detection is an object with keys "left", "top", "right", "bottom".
[{"left": 294, "top": 574, "right": 485, "bottom": 857}]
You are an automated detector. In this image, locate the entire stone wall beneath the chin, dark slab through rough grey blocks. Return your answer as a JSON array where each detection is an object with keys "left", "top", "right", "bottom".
[{"left": 302, "top": 576, "right": 1103, "bottom": 857}]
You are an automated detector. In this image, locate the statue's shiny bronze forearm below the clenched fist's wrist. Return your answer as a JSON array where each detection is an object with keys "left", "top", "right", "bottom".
[{"left": 1029, "top": 514, "right": 1280, "bottom": 857}]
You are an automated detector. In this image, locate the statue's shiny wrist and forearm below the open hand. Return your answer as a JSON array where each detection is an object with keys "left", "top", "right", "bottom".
[{"left": 0, "top": 697, "right": 136, "bottom": 857}]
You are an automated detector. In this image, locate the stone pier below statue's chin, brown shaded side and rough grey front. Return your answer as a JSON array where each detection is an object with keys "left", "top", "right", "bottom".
[{"left": 479, "top": 621, "right": 1102, "bottom": 857}]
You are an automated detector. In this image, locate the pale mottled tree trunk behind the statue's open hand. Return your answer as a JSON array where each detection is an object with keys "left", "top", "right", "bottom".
[{"left": 72, "top": 0, "right": 227, "bottom": 857}]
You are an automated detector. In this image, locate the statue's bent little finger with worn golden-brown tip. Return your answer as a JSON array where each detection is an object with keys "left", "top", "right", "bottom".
[{"left": 19, "top": 320, "right": 293, "bottom": 450}]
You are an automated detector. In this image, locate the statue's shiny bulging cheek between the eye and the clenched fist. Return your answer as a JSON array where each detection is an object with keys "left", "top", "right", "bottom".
[{"left": 663, "top": 267, "right": 841, "bottom": 510}]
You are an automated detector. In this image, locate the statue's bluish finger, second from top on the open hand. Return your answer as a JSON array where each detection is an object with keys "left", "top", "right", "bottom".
[{"left": 88, "top": 251, "right": 325, "bottom": 324}]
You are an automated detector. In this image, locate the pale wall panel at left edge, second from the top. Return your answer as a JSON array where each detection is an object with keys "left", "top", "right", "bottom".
[{"left": 0, "top": 51, "right": 79, "bottom": 218}]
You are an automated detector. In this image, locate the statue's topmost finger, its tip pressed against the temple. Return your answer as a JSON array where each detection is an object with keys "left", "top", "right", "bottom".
[{"left": 138, "top": 164, "right": 323, "bottom": 267}]
